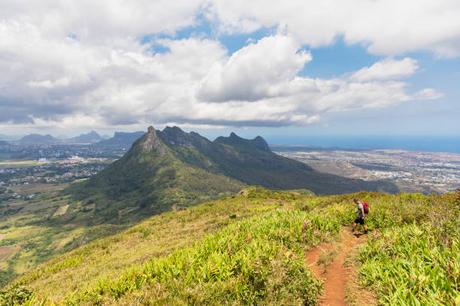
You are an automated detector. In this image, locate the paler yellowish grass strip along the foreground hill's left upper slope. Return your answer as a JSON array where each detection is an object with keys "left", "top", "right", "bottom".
[{"left": 9, "top": 189, "right": 288, "bottom": 301}]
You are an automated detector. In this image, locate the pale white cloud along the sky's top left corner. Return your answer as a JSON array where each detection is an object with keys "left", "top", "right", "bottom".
[{"left": 0, "top": 0, "right": 203, "bottom": 41}]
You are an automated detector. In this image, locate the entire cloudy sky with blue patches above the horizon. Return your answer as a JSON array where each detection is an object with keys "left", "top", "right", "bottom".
[{"left": 0, "top": 0, "right": 460, "bottom": 135}]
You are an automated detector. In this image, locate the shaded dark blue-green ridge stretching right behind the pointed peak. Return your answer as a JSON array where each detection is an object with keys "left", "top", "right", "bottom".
[{"left": 156, "top": 127, "right": 398, "bottom": 194}]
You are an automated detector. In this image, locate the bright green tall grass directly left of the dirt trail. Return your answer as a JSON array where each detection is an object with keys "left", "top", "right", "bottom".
[{"left": 67, "top": 211, "right": 341, "bottom": 305}]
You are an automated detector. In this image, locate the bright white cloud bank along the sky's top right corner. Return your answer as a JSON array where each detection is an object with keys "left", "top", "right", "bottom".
[{"left": 209, "top": 0, "right": 460, "bottom": 57}]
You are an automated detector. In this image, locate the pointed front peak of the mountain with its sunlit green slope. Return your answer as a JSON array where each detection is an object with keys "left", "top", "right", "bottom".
[{"left": 70, "top": 127, "right": 243, "bottom": 223}]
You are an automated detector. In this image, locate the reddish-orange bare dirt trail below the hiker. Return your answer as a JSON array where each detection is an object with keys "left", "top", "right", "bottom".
[{"left": 306, "top": 228, "right": 366, "bottom": 306}]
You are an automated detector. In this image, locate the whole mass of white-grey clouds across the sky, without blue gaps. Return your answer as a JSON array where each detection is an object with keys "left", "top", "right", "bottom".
[{"left": 0, "top": 0, "right": 448, "bottom": 128}]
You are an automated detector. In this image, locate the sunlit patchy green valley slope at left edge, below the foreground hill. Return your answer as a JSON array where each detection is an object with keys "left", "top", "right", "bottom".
[{"left": 0, "top": 186, "right": 123, "bottom": 286}]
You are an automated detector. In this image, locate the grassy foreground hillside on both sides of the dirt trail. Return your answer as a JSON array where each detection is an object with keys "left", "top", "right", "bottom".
[{"left": 1, "top": 188, "right": 460, "bottom": 305}]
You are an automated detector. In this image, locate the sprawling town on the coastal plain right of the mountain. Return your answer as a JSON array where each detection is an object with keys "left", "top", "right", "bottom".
[{"left": 275, "top": 147, "right": 460, "bottom": 193}]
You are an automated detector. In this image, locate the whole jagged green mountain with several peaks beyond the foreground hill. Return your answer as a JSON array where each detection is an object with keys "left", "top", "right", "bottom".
[{"left": 69, "top": 127, "right": 398, "bottom": 222}]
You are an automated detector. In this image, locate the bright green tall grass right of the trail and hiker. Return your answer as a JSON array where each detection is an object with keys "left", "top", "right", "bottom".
[{"left": 359, "top": 194, "right": 460, "bottom": 305}]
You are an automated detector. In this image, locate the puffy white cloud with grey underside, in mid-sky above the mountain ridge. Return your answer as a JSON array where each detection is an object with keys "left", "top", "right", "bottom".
[{"left": 198, "top": 35, "right": 311, "bottom": 102}]
